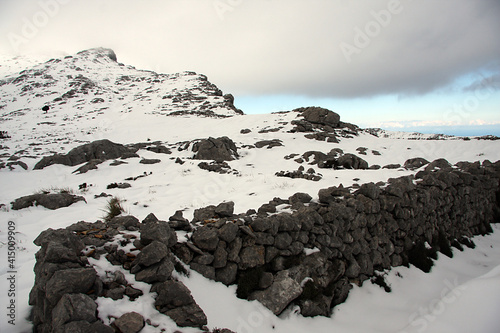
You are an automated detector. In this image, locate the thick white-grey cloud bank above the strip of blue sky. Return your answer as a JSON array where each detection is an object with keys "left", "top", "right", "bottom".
[{"left": 0, "top": 0, "right": 500, "bottom": 98}]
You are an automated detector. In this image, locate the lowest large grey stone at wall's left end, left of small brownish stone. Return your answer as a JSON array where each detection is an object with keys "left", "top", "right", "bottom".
[{"left": 52, "top": 294, "right": 97, "bottom": 329}]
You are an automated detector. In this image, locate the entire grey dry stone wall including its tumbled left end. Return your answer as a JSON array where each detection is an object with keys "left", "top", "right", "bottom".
[{"left": 30, "top": 160, "right": 500, "bottom": 332}]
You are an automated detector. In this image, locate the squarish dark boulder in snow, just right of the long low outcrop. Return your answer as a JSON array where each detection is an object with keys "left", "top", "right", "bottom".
[{"left": 193, "top": 136, "right": 238, "bottom": 162}]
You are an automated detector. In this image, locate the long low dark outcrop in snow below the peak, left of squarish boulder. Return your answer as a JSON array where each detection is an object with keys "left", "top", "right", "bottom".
[{"left": 33, "top": 139, "right": 139, "bottom": 170}]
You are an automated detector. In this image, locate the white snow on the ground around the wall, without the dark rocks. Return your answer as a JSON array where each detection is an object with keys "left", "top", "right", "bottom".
[{"left": 0, "top": 50, "right": 500, "bottom": 333}]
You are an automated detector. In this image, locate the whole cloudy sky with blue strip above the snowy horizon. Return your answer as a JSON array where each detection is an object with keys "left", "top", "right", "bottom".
[{"left": 0, "top": 0, "right": 500, "bottom": 135}]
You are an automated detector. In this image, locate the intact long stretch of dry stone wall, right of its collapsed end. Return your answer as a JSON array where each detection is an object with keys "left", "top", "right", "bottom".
[{"left": 173, "top": 160, "right": 500, "bottom": 316}]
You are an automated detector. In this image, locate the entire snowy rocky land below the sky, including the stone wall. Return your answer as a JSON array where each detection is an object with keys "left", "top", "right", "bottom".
[{"left": 0, "top": 48, "right": 500, "bottom": 333}]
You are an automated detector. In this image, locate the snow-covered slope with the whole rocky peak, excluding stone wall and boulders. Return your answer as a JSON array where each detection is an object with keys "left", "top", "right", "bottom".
[{"left": 0, "top": 49, "right": 500, "bottom": 333}]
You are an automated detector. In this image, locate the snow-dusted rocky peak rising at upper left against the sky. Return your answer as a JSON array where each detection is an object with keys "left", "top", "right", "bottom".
[{"left": 0, "top": 48, "right": 242, "bottom": 160}]
